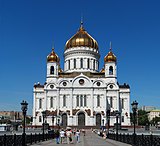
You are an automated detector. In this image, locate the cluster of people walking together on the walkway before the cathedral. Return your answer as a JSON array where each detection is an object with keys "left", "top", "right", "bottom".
[{"left": 55, "top": 129, "right": 82, "bottom": 144}]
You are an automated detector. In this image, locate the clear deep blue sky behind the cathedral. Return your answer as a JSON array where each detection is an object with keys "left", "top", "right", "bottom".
[{"left": 0, "top": 0, "right": 160, "bottom": 114}]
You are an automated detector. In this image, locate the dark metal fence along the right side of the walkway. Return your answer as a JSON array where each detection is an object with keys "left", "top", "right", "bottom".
[{"left": 108, "top": 134, "right": 160, "bottom": 146}]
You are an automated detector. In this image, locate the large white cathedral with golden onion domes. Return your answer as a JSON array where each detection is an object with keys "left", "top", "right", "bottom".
[{"left": 32, "top": 22, "right": 130, "bottom": 127}]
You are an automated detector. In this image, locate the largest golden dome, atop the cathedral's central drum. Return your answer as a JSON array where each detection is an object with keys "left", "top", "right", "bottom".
[{"left": 65, "top": 22, "right": 98, "bottom": 50}]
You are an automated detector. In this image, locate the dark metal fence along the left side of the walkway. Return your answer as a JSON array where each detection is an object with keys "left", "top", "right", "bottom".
[{"left": 0, "top": 133, "right": 55, "bottom": 146}]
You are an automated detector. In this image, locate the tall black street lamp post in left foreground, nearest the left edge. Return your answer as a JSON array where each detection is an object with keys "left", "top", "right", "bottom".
[{"left": 21, "top": 100, "right": 28, "bottom": 146}]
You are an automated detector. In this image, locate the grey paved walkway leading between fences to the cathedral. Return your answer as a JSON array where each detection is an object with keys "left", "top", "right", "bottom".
[{"left": 29, "top": 131, "right": 131, "bottom": 146}]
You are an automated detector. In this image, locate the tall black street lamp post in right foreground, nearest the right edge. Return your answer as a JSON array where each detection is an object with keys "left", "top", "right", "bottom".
[{"left": 131, "top": 100, "right": 138, "bottom": 145}]
